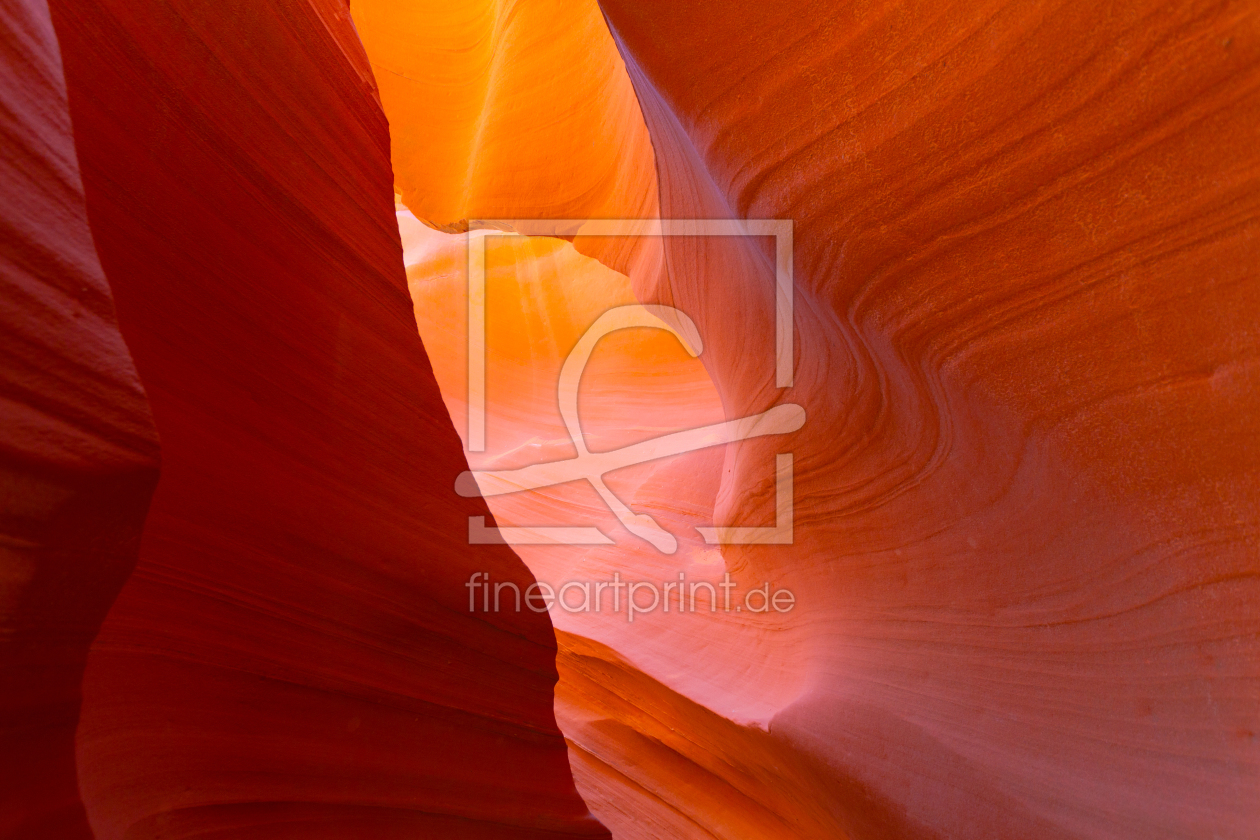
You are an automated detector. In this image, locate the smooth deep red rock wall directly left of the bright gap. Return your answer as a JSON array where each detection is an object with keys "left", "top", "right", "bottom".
[{"left": 29, "top": 0, "right": 607, "bottom": 840}]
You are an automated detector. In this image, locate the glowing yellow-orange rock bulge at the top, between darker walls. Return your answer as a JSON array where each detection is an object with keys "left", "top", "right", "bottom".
[{"left": 352, "top": 0, "right": 656, "bottom": 230}]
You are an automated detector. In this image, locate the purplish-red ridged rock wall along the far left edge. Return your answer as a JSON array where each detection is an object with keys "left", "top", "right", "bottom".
[{"left": 0, "top": 0, "right": 158, "bottom": 840}]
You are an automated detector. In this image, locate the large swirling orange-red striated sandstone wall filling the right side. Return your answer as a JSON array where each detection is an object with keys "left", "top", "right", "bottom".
[{"left": 597, "top": 0, "right": 1260, "bottom": 837}]
